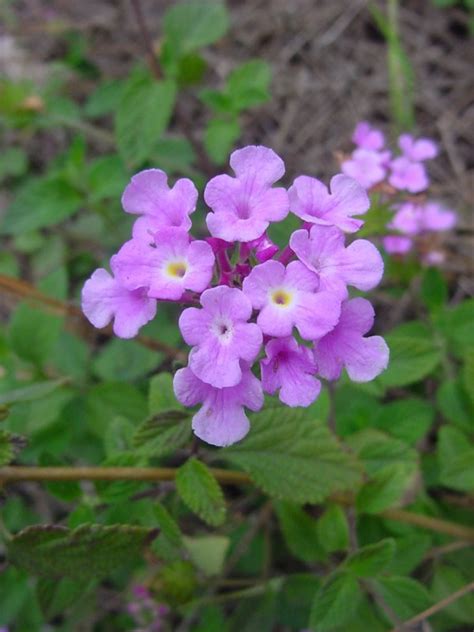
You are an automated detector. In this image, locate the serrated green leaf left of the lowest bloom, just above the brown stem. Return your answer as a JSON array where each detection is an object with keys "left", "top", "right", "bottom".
[{"left": 133, "top": 410, "right": 191, "bottom": 457}]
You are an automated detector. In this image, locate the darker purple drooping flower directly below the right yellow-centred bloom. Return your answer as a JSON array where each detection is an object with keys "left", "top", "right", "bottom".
[{"left": 260, "top": 336, "right": 321, "bottom": 407}]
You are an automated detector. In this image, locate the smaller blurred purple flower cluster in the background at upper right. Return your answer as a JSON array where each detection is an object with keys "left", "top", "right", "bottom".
[{"left": 341, "top": 121, "right": 456, "bottom": 265}]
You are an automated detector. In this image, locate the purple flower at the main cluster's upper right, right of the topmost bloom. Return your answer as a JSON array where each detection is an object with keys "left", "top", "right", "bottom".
[{"left": 288, "top": 173, "right": 370, "bottom": 233}]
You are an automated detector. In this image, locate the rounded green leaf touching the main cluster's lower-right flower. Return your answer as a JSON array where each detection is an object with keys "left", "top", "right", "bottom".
[{"left": 378, "top": 321, "right": 441, "bottom": 387}]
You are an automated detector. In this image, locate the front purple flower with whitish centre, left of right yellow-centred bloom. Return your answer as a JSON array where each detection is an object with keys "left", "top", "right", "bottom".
[{"left": 179, "top": 285, "right": 262, "bottom": 388}]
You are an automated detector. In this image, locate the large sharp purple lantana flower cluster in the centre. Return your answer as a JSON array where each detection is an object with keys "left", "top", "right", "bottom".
[{"left": 82, "top": 146, "right": 389, "bottom": 446}]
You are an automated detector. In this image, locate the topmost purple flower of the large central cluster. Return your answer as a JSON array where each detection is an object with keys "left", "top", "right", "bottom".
[{"left": 204, "top": 145, "right": 289, "bottom": 242}]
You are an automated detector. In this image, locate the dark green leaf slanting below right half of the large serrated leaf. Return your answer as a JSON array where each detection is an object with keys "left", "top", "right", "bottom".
[{"left": 273, "top": 500, "right": 326, "bottom": 563}]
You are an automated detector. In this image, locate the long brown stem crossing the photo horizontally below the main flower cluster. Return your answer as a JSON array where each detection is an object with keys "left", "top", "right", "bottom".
[{"left": 0, "top": 465, "right": 474, "bottom": 542}]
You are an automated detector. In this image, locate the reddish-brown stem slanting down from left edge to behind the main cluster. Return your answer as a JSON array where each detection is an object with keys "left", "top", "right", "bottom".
[{"left": 0, "top": 274, "right": 186, "bottom": 362}]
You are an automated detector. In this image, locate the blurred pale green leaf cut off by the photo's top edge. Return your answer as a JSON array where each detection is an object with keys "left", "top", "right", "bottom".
[{"left": 163, "top": 0, "right": 229, "bottom": 58}]
